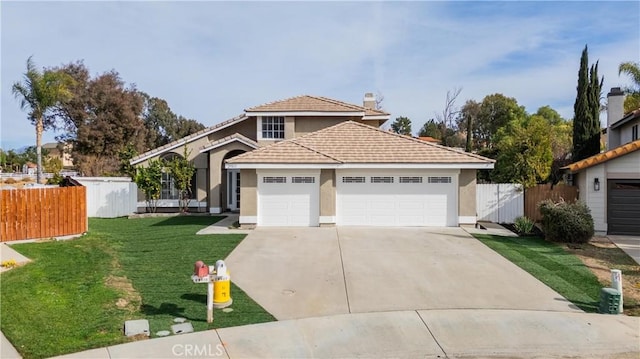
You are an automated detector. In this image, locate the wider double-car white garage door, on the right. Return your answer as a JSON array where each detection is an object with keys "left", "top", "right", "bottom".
[{"left": 336, "top": 170, "right": 458, "bottom": 227}]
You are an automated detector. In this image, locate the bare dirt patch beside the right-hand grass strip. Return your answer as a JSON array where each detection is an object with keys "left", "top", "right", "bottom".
[{"left": 562, "top": 236, "right": 640, "bottom": 316}]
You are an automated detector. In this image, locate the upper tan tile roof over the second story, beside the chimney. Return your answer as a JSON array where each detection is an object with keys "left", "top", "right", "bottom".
[{"left": 245, "top": 95, "right": 389, "bottom": 116}]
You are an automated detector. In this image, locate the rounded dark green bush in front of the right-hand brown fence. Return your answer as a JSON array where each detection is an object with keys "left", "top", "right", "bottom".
[{"left": 538, "top": 200, "right": 594, "bottom": 243}]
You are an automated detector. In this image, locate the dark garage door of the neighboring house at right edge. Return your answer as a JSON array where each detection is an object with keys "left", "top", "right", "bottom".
[{"left": 607, "top": 179, "right": 640, "bottom": 235}]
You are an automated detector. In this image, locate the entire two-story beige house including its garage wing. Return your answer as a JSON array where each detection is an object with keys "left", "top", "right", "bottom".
[{"left": 132, "top": 94, "right": 494, "bottom": 226}]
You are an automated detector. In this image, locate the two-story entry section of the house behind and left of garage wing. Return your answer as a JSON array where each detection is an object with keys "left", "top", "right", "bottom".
[{"left": 131, "top": 94, "right": 389, "bottom": 213}]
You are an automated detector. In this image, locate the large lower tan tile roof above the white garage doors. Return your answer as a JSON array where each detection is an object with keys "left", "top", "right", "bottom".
[{"left": 227, "top": 121, "right": 495, "bottom": 164}]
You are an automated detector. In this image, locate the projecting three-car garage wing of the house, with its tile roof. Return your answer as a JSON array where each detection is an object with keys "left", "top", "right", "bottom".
[{"left": 226, "top": 121, "right": 494, "bottom": 227}]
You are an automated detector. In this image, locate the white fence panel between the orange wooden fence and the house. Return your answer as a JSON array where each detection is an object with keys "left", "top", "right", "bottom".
[{"left": 73, "top": 177, "right": 138, "bottom": 218}]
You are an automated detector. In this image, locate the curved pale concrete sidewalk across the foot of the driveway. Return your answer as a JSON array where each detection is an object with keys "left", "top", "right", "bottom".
[{"left": 53, "top": 310, "right": 640, "bottom": 359}]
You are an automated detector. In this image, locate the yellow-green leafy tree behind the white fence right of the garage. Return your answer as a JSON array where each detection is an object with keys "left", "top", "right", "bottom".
[{"left": 491, "top": 115, "right": 553, "bottom": 188}]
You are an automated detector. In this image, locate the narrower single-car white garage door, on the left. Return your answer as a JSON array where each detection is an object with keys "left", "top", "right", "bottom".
[{"left": 258, "top": 171, "right": 320, "bottom": 227}]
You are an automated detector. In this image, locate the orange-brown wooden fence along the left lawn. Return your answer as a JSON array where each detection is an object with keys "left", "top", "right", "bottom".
[{"left": 0, "top": 186, "right": 87, "bottom": 242}]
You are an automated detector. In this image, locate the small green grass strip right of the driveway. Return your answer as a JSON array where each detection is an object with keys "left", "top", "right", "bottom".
[{"left": 474, "top": 234, "right": 602, "bottom": 312}]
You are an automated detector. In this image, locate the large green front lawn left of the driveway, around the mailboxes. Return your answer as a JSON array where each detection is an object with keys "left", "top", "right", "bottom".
[{"left": 0, "top": 216, "right": 275, "bottom": 358}]
